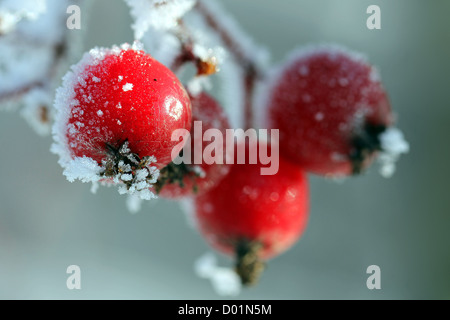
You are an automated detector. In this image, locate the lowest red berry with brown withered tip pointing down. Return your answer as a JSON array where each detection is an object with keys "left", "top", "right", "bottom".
[{"left": 195, "top": 142, "right": 309, "bottom": 284}]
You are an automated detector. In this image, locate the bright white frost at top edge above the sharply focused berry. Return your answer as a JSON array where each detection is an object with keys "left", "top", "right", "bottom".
[{"left": 126, "top": 0, "right": 196, "bottom": 40}]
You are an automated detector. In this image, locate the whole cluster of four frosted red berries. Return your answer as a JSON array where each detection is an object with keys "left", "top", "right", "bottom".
[{"left": 53, "top": 42, "right": 393, "bottom": 284}]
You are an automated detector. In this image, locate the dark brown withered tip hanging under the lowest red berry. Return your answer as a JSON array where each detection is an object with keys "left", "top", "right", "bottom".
[{"left": 235, "top": 239, "right": 265, "bottom": 286}]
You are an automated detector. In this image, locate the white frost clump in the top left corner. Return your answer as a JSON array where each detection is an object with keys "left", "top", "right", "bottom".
[{"left": 0, "top": 0, "right": 46, "bottom": 34}]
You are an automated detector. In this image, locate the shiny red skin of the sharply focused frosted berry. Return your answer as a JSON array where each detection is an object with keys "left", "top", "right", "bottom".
[{"left": 66, "top": 48, "right": 192, "bottom": 168}]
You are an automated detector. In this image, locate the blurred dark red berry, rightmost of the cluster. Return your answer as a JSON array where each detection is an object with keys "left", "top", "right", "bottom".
[{"left": 268, "top": 47, "right": 393, "bottom": 176}]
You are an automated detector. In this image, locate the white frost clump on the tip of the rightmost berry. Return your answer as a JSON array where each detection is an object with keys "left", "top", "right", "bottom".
[{"left": 378, "top": 128, "right": 409, "bottom": 178}]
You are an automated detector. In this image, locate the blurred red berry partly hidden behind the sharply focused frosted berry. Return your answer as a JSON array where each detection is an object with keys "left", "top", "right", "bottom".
[{"left": 156, "top": 93, "right": 230, "bottom": 199}]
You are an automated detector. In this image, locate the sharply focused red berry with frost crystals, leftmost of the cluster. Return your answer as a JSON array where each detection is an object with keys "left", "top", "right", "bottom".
[{"left": 53, "top": 45, "right": 192, "bottom": 198}]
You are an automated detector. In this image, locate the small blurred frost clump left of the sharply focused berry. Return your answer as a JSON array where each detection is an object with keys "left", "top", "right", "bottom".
[{"left": 20, "top": 88, "right": 52, "bottom": 136}]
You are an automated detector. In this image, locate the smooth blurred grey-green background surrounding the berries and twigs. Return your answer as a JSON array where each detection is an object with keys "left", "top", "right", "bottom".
[{"left": 0, "top": 0, "right": 450, "bottom": 299}]
